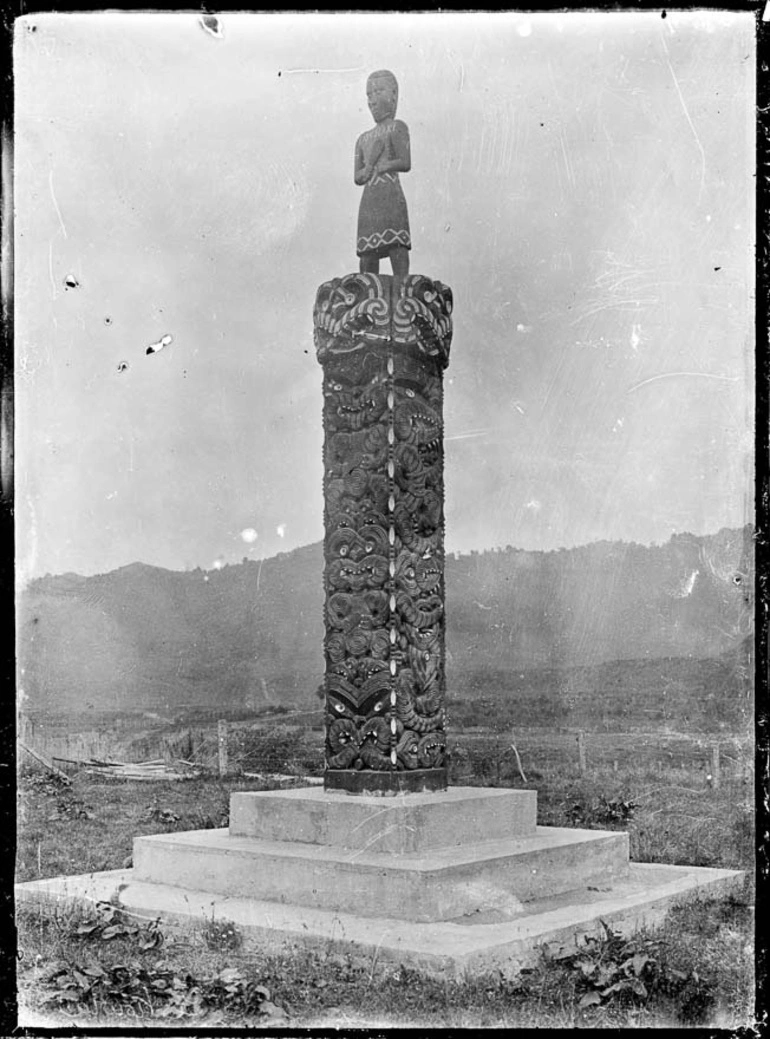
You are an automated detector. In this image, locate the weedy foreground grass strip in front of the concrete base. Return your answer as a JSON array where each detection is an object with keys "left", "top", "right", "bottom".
[{"left": 18, "top": 898, "right": 753, "bottom": 1029}]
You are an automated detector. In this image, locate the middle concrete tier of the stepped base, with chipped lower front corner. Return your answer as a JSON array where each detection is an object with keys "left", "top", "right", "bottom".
[{"left": 134, "top": 826, "right": 629, "bottom": 922}]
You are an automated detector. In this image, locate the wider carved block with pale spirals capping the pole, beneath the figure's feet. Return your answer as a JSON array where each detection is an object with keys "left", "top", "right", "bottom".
[{"left": 313, "top": 273, "right": 452, "bottom": 369}]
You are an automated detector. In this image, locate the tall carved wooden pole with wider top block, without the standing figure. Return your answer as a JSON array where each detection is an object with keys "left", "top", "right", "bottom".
[{"left": 314, "top": 273, "right": 452, "bottom": 793}]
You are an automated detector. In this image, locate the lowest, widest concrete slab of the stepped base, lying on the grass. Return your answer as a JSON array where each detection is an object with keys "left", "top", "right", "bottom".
[{"left": 17, "top": 863, "right": 743, "bottom": 977}]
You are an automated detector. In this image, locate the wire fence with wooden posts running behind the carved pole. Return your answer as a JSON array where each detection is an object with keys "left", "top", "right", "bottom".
[{"left": 20, "top": 709, "right": 754, "bottom": 789}]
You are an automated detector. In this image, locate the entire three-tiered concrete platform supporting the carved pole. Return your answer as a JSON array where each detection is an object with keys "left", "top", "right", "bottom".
[{"left": 17, "top": 788, "right": 743, "bottom": 976}]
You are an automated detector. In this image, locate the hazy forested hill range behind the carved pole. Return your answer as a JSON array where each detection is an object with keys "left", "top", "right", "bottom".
[{"left": 17, "top": 527, "right": 753, "bottom": 712}]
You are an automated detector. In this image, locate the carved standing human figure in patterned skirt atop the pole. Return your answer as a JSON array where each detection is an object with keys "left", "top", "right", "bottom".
[{"left": 353, "top": 69, "right": 411, "bottom": 283}]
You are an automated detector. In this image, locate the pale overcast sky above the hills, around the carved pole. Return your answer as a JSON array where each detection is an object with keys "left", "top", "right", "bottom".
[{"left": 15, "top": 11, "right": 754, "bottom": 579}]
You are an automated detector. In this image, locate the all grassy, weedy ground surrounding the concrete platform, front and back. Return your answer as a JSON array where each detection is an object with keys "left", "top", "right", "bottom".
[{"left": 18, "top": 739, "right": 753, "bottom": 1028}]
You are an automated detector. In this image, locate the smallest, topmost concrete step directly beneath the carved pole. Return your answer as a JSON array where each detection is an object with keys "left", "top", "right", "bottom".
[{"left": 230, "top": 787, "right": 537, "bottom": 855}]
